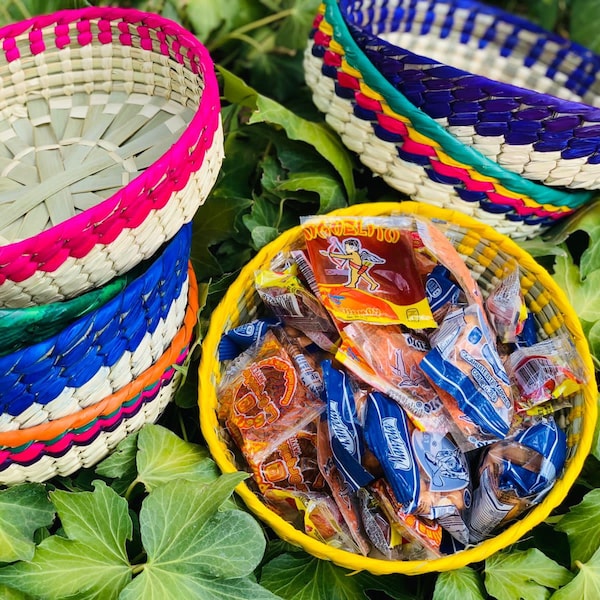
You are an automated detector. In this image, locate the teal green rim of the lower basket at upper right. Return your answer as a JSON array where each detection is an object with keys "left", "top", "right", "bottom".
[{"left": 322, "top": 0, "right": 593, "bottom": 208}]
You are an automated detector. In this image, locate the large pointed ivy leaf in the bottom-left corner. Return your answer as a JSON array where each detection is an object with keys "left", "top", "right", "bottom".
[{"left": 0, "top": 481, "right": 132, "bottom": 600}]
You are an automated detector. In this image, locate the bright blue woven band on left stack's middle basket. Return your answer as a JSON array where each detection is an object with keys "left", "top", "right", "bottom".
[{"left": 0, "top": 224, "right": 192, "bottom": 415}]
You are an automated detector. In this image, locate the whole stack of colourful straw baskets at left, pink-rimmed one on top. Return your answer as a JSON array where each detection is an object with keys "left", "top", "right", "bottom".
[{"left": 0, "top": 8, "right": 223, "bottom": 484}]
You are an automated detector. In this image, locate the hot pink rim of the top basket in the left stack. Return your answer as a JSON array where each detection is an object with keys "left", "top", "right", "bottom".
[{"left": 0, "top": 6, "right": 221, "bottom": 260}]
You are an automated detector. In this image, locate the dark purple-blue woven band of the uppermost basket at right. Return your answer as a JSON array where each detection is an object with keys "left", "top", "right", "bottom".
[{"left": 340, "top": 0, "right": 600, "bottom": 164}]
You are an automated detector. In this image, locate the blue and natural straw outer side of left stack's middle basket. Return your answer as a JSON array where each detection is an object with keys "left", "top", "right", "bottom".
[{"left": 0, "top": 223, "right": 192, "bottom": 431}]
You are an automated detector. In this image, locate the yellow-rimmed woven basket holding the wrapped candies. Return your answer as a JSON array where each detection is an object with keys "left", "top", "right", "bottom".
[{"left": 199, "top": 202, "right": 597, "bottom": 575}]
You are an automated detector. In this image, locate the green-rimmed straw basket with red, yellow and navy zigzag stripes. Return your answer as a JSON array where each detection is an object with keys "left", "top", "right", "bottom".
[{"left": 304, "top": 0, "right": 592, "bottom": 239}]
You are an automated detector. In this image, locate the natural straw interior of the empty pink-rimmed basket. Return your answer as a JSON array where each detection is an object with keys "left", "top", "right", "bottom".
[{"left": 0, "top": 19, "right": 204, "bottom": 244}]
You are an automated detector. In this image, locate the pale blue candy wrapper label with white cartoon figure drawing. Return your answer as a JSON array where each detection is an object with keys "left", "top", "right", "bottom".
[{"left": 412, "top": 429, "right": 469, "bottom": 492}]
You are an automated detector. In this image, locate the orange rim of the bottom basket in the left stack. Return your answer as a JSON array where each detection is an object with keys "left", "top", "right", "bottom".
[{"left": 0, "top": 261, "right": 199, "bottom": 448}]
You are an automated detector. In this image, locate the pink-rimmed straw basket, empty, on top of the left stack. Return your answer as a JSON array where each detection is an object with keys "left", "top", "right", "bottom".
[{"left": 0, "top": 7, "right": 223, "bottom": 307}]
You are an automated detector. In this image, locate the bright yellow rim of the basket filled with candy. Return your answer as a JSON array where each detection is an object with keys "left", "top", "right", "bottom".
[{"left": 199, "top": 201, "right": 598, "bottom": 575}]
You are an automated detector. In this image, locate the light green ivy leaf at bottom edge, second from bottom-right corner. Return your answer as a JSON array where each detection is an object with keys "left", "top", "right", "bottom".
[{"left": 485, "top": 548, "right": 573, "bottom": 600}]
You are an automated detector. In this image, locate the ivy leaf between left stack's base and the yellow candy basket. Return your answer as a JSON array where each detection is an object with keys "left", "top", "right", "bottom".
[{"left": 137, "top": 424, "right": 218, "bottom": 491}]
